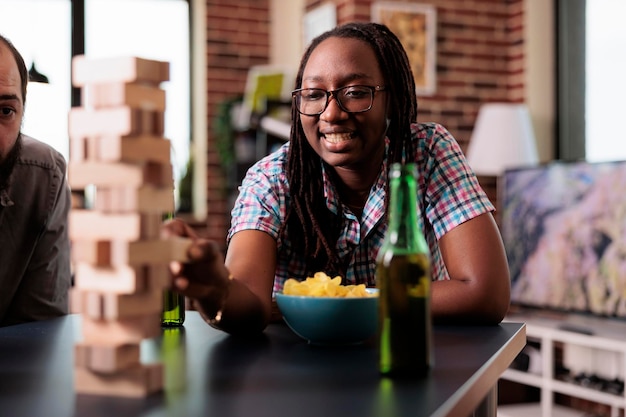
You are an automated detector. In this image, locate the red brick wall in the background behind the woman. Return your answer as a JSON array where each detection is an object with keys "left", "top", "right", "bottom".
[{"left": 207, "top": 0, "right": 525, "bottom": 242}]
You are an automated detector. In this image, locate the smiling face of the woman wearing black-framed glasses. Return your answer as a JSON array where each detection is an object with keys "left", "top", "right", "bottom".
[{"left": 300, "top": 37, "right": 387, "bottom": 172}]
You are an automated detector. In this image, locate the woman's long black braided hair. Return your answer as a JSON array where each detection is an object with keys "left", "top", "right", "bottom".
[{"left": 280, "top": 22, "right": 417, "bottom": 277}]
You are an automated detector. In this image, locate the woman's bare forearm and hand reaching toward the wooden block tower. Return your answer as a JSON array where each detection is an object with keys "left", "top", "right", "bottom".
[{"left": 162, "top": 219, "right": 276, "bottom": 335}]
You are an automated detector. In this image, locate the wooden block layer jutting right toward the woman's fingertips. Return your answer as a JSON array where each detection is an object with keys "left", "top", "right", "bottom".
[{"left": 72, "top": 237, "right": 191, "bottom": 267}]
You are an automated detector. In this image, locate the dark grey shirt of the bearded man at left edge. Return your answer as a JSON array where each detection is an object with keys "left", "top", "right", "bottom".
[{"left": 0, "top": 135, "right": 71, "bottom": 326}]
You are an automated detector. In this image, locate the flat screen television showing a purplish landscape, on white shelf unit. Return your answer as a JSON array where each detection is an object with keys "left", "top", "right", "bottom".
[{"left": 498, "top": 161, "right": 626, "bottom": 318}]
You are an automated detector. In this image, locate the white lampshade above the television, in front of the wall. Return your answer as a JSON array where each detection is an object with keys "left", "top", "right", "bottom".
[{"left": 467, "top": 103, "right": 539, "bottom": 176}]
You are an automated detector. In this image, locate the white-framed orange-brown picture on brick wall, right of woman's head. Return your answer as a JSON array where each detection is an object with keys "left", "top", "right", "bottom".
[{"left": 371, "top": 1, "right": 437, "bottom": 96}]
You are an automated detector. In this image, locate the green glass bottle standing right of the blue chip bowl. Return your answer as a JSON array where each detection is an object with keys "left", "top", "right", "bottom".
[{"left": 376, "top": 163, "right": 433, "bottom": 376}]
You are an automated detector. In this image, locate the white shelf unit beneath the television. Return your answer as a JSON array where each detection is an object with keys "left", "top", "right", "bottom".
[{"left": 498, "top": 312, "right": 626, "bottom": 417}]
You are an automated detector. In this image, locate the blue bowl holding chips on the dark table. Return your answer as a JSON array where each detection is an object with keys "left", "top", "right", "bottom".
[{"left": 276, "top": 288, "right": 378, "bottom": 345}]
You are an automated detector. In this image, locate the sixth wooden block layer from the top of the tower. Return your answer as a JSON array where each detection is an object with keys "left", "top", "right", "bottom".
[{"left": 94, "top": 185, "right": 176, "bottom": 213}]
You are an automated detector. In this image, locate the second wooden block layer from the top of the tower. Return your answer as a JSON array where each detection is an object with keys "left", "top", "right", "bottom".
[{"left": 83, "top": 82, "right": 165, "bottom": 112}]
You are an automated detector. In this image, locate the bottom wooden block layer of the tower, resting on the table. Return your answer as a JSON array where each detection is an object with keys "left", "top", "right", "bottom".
[{"left": 74, "top": 363, "right": 164, "bottom": 398}]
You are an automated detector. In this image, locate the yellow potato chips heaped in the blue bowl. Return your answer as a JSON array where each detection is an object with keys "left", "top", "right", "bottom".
[{"left": 283, "top": 272, "right": 375, "bottom": 298}]
